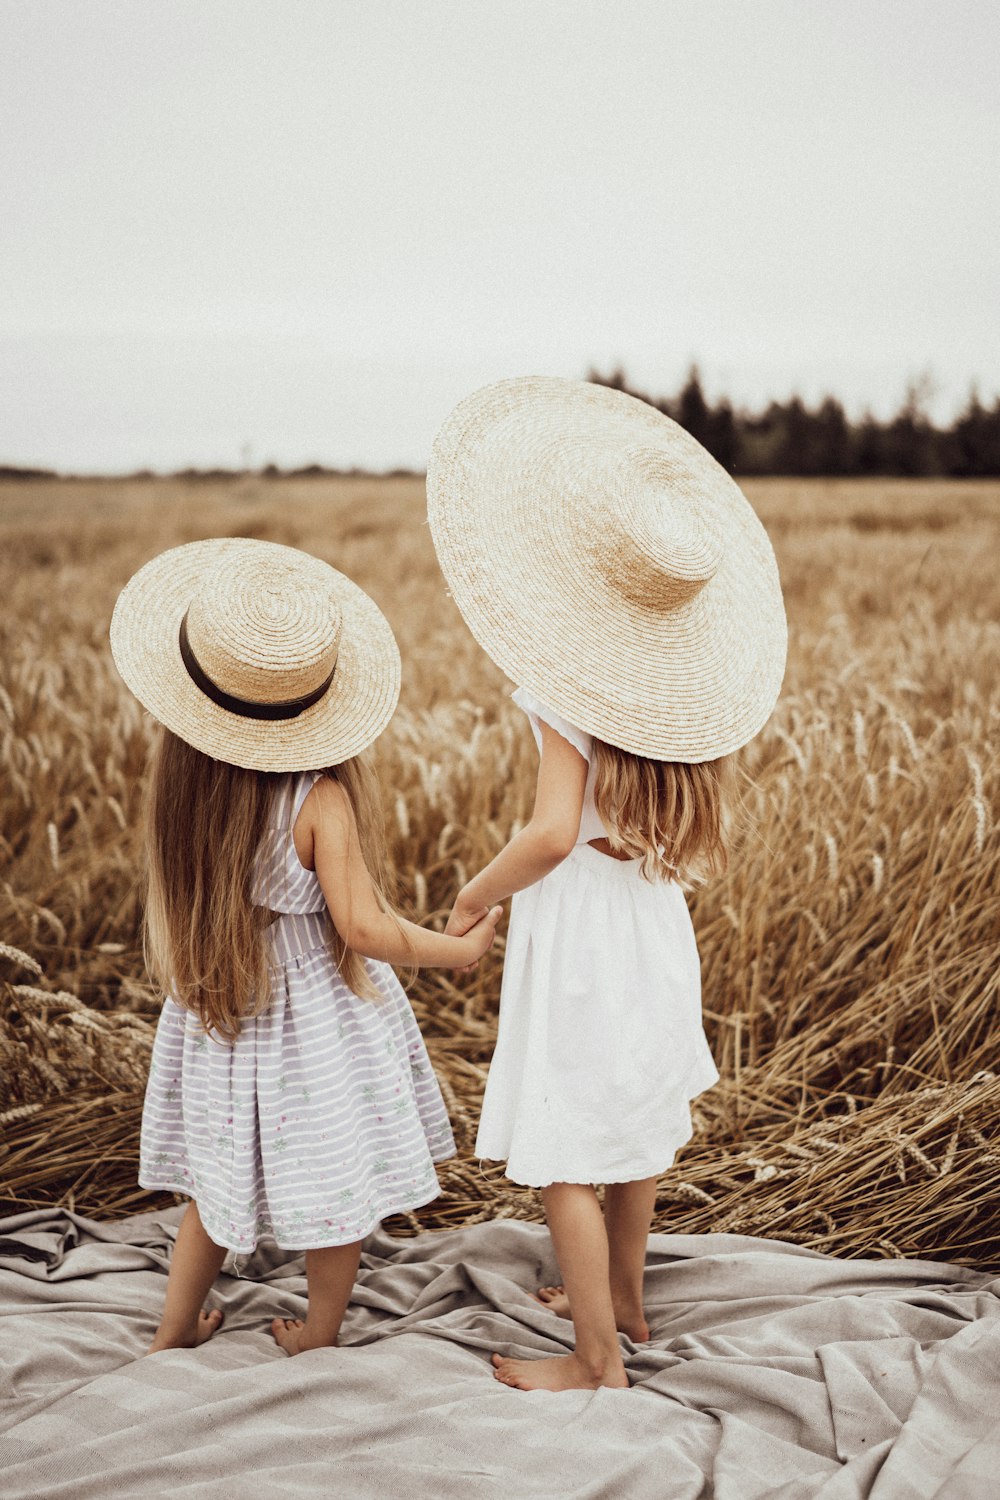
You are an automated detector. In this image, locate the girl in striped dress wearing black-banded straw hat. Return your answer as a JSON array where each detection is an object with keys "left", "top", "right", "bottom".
[{"left": 112, "top": 540, "right": 499, "bottom": 1355}]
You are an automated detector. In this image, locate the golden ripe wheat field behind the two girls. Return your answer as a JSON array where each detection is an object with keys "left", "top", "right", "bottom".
[{"left": 0, "top": 476, "right": 1000, "bottom": 1269}]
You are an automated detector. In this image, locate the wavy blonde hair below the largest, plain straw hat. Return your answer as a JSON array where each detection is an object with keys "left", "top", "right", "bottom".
[{"left": 594, "top": 740, "right": 739, "bottom": 884}]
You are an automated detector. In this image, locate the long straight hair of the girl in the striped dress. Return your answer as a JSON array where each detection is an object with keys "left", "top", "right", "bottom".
[{"left": 144, "top": 729, "right": 387, "bottom": 1043}]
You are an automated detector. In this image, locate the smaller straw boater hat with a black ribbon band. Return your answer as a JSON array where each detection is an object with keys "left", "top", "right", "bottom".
[{"left": 111, "top": 537, "right": 399, "bottom": 771}]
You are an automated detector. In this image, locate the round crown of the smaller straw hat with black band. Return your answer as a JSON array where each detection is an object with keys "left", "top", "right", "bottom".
[{"left": 186, "top": 558, "right": 342, "bottom": 704}]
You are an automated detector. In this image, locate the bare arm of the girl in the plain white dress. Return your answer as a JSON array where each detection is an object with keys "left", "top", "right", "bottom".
[{"left": 445, "top": 722, "right": 588, "bottom": 933}]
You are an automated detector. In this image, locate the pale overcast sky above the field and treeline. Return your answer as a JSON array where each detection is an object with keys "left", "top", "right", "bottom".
[{"left": 0, "top": 0, "right": 1000, "bottom": 470}]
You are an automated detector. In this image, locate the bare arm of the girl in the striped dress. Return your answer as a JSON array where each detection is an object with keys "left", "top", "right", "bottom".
[{"left": 295, "top": 777, "right": 501, "bottom": 969}]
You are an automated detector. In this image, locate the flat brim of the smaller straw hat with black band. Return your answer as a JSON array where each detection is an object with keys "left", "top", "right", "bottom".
[{"left": 111, "top": 537, "right": 400, "bottom": 771}]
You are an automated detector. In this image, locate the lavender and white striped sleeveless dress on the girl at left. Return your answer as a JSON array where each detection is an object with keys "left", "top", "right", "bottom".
[{"left": 139, "top": 773, "right": 454, "bottom": 1251}]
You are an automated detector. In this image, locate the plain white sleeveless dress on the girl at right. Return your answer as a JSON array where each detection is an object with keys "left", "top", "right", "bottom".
[{"left": 475, "top": 689, "right": 718, "bottom": 1187}]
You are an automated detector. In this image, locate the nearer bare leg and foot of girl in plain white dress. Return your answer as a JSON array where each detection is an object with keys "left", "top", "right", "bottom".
[{"left": 493, "top": 1182, "right": 628, "bottom": 1391}]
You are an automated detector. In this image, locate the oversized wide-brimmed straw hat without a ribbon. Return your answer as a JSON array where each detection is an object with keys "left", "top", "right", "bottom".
[{"left": 427, "top": 377, "right": 787, "bottom": 762}]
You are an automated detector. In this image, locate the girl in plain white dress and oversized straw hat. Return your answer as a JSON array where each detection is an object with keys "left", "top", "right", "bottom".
[{"left": 427, "top": 378, "right": 786, "bottom": 1391}]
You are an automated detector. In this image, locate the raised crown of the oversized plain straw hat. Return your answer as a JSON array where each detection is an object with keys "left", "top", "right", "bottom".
[{"left": 594, "top": 449, "right": 723, "bottom": 611}]
